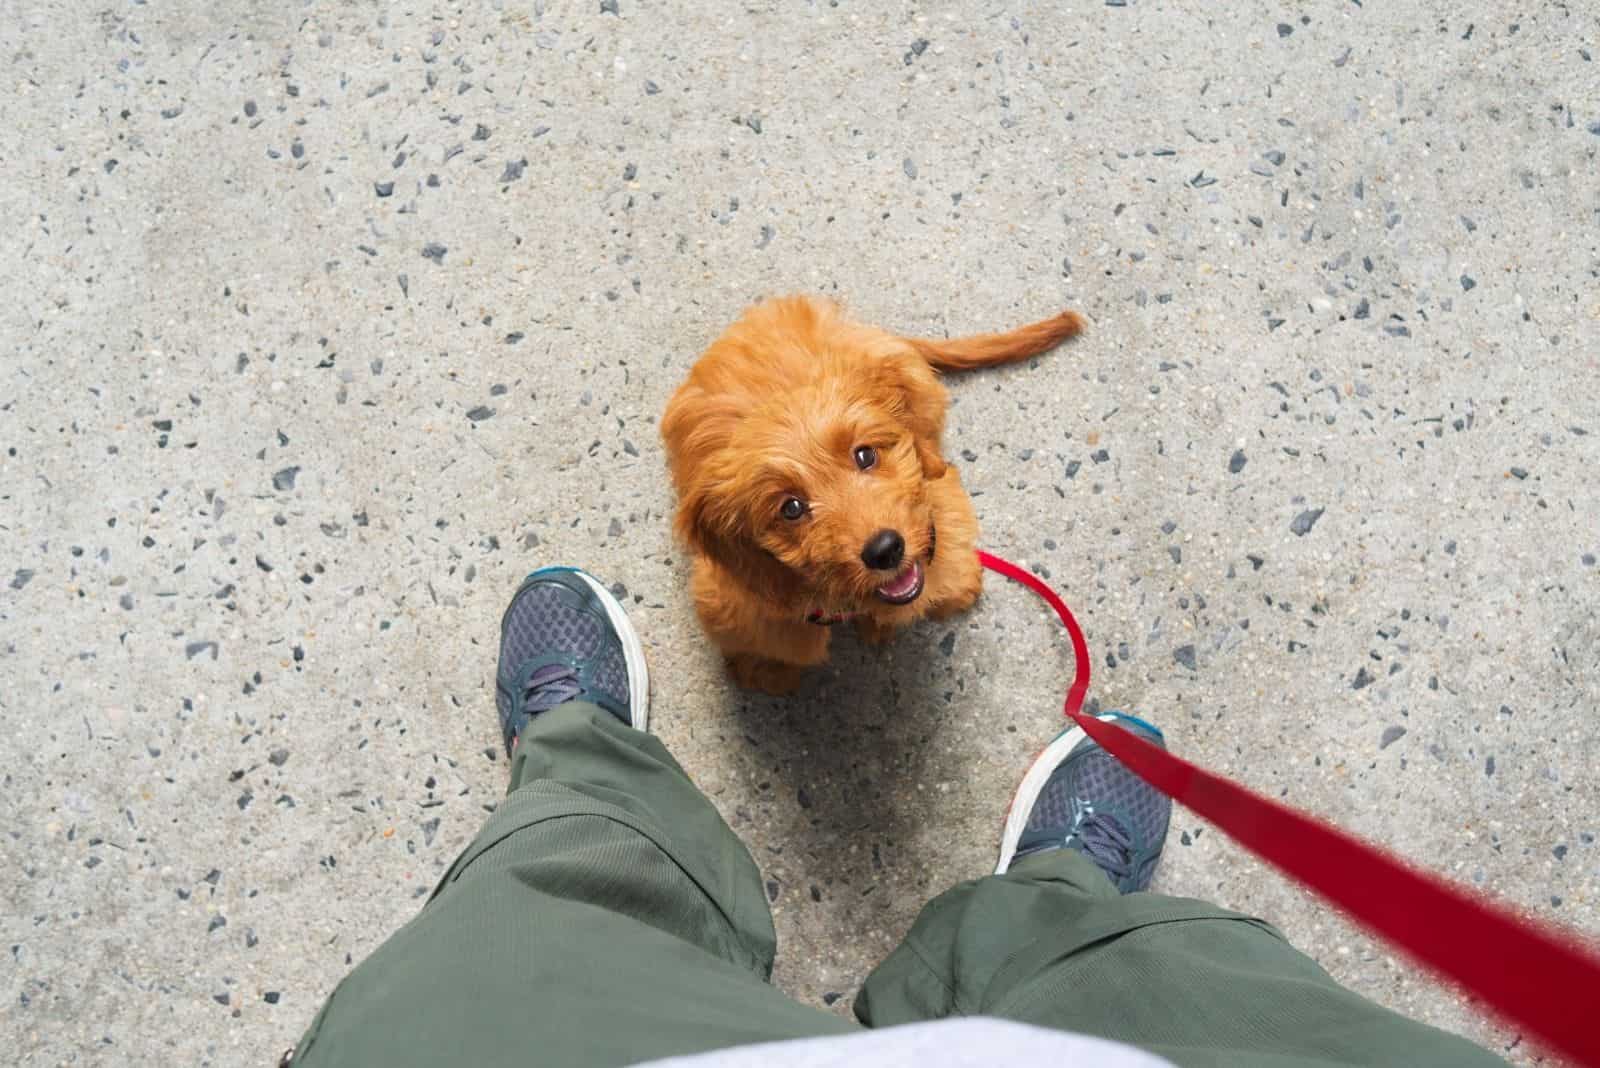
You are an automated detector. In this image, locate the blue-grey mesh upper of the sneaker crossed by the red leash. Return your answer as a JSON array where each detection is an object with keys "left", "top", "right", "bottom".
[{"left": 1016, "top": 716, "right": 1173, "bottom": 894}]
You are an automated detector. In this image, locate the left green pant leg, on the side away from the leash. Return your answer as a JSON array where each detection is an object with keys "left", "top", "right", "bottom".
[{"left": 294, "top": 703, "right": 854, "bottom": 1068}]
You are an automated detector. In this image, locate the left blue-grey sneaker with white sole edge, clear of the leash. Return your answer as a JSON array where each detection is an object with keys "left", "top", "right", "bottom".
[{"left": 494, "top": 568, "right": 650, "bottom": 755}]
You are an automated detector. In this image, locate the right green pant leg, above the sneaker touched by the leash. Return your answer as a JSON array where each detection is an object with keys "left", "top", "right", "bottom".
[{"left": 854, "top": 851, "right": 1504, "bottom": 1068}]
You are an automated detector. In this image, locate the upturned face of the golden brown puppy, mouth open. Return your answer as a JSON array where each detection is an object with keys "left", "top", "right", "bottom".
[{"left": 680, "top": 371, "right": 933, "bottom": 617}]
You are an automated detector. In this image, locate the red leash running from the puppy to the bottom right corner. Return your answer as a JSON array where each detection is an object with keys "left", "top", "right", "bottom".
[{"left": 978, "top": 550, "right": 1600, "bottom": 1066}]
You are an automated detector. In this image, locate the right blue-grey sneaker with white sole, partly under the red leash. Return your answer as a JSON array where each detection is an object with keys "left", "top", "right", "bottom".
[{"left": 995, "top": 711, "right": 1173, "bottom": 894}]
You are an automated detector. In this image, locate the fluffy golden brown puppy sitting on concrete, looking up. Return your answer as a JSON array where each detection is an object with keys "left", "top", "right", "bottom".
[{"left": 661, "top": 297, "right": 1083, "bottom": 694}]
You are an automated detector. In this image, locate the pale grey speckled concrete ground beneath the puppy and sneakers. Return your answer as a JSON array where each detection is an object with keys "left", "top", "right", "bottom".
[{"left": 0, "top": 0, "right": 1600, "bottom": 1065}]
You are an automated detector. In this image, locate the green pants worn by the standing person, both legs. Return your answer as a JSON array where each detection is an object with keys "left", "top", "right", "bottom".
[{"left": 294, "top": 703, "right": 1502, "bottom": 1068}]
